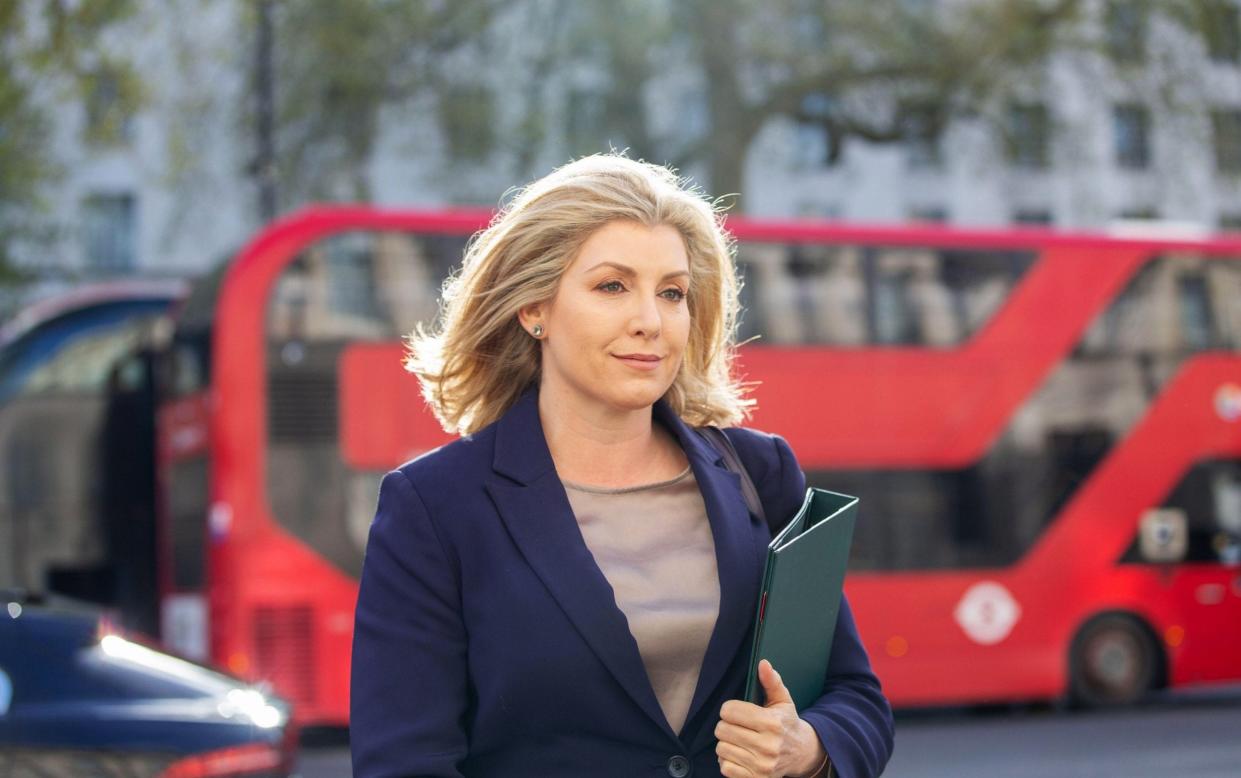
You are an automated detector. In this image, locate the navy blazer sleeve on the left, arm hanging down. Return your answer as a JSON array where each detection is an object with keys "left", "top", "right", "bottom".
[{"left": 350, "top": 470, "right": 468, "bottom": 778}]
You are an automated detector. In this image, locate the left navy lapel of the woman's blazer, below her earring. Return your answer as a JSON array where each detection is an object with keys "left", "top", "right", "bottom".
[{"left": 486, "top": 390, "right": 676, "bottom": 740}]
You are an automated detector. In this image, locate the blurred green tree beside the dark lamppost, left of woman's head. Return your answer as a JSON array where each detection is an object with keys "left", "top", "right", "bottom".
[{"left": 254, "top": 0, "right": 504, "bottom": 203}]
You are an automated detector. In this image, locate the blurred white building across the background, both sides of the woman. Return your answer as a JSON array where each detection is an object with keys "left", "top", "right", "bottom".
[{"left": 26, "top": 0, "right": 1241, "bottom": 286}]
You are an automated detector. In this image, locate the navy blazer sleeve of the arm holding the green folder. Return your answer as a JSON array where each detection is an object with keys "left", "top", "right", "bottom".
[{"left": 759, "top": 436, "right": 895, "bottom": 778}]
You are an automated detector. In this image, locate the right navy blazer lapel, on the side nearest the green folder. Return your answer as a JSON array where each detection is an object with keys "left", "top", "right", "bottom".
[{"left": 655, "top": 402, "right": 771, "bottom": 726}]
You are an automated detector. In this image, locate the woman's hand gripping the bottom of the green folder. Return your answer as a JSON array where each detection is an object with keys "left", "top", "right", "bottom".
[{"left": 715, "top": 659, "right": 827, "bottom": 778}]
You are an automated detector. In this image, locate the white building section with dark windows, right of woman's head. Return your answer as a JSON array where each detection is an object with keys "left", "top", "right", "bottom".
[{"left": 747, "top": 0, "right": 1241, "bottom": 231}]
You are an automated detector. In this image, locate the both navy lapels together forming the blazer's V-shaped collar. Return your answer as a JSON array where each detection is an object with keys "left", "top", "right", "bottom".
[{"left": 486, "top": 387, "right": 768, "bottom": 738}]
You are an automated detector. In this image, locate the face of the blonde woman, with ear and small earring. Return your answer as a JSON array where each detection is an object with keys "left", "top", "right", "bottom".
[{"left": 522, "top": 221, "right": 690, "bottom": 419}]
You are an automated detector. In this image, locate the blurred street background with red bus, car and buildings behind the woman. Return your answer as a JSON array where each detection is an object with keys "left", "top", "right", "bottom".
[{"left": 0, "top": 0, "right": 1241, "bottom": 776}]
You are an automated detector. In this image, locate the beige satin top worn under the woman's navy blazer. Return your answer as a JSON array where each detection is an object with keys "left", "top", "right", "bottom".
[{"left": 563, "top": 468, "right": 720, "bottom": 732}]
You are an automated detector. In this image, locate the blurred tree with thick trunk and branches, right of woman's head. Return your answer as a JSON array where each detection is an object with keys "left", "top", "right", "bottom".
[{"left": 679, "top": 0, "right": 1083, "bottom": 203}]
